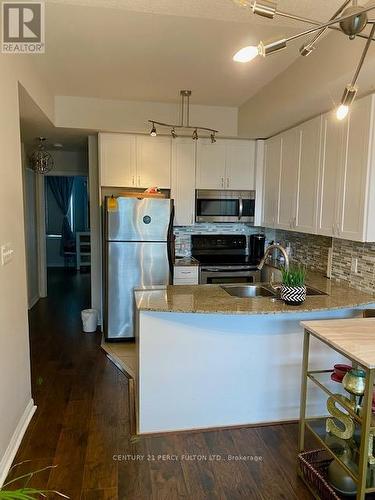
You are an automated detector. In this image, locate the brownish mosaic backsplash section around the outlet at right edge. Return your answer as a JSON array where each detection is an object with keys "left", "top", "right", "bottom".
[{"left": 332, "top": 239, "right": 375, "bottom": 293}]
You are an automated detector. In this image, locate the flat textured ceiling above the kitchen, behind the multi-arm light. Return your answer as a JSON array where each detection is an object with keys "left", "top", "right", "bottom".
[{"left": 31, "top": 0, "right": 370, "bottom": 106}]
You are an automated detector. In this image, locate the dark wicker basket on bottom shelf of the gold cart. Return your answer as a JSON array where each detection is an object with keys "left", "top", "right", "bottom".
[{"left": 298, "top": 450, "right": 341, "bottom": 500}]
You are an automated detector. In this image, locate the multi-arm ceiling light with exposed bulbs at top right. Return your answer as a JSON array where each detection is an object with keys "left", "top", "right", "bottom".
[{"left": 233, "top": 0, "right": 375, "bottom": 120}]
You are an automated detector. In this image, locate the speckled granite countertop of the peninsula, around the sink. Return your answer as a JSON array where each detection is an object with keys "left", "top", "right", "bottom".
[{"left": 135, "top": 273, "right": 375, "bottom": 315}]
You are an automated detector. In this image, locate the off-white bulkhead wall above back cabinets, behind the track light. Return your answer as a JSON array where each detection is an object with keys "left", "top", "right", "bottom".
[{"left": 55, "top": 96, "right": 238, "bottom": 137}]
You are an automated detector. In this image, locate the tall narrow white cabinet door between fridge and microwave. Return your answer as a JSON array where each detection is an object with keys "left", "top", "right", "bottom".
[{"left": 171, "top": 138, "right": 196, "bottom": 226}]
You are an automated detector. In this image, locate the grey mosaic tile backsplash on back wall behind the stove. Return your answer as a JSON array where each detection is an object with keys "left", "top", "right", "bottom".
[{"left": 173, "top": 223, "right": 264, "bottom": 256}]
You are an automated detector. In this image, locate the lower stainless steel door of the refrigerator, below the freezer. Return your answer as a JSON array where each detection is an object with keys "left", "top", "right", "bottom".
[{"left": 105, "top": 242, "right": 170, "bottom": 340}]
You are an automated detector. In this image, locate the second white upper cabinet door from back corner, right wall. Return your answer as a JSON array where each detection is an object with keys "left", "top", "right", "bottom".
[{"left": 276, "top": 128, "right": 300, "bottom": 229}]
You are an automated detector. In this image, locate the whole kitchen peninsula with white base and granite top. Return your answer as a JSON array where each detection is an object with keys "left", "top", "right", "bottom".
[{"left": 135, "top": 273, "right": 375, "bottom": 434}]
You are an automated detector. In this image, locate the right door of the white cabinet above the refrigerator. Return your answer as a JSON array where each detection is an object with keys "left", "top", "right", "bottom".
[{"left": 137, "top": 136, "right": 172, "bottom": 189}]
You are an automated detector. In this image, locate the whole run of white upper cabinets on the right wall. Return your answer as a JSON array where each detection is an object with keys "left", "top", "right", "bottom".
[{"left": 263, "top": 95, "right": 375, "bottom": 242}]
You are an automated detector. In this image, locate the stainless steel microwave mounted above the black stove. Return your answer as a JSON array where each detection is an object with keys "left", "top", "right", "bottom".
[{"left": 195, "top": 189, "right": 255, "bottom": 224}]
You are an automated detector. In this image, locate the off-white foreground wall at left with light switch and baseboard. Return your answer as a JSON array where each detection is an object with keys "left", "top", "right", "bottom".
[{"left": 0, "top": 54, "right": 54, "bottom": 484}]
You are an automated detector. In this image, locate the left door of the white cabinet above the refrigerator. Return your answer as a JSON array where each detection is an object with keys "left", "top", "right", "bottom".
[{"left": 99, "top": 134, "right": 135, "bottom": 187}]
